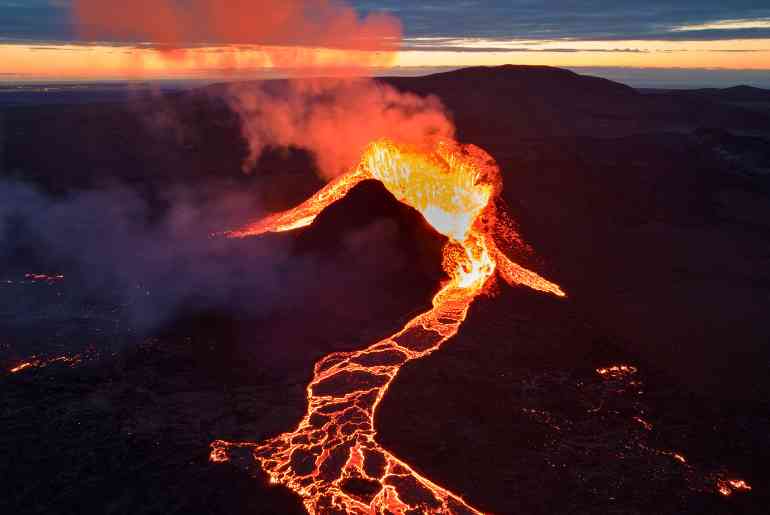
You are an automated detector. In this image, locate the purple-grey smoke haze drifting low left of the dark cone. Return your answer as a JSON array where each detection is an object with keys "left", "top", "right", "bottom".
[{"left": 0, "top": 182, "right": 287, "bottom": 330}]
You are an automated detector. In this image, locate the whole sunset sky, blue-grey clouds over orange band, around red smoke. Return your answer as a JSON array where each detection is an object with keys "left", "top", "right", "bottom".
[{"left": 0, "top": 0, "right": 770, "bottom": 86}]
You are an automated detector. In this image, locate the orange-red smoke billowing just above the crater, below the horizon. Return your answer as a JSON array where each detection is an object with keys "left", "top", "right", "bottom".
[{"left": 229, "top": 79, "right": 454, "bottom": 180}]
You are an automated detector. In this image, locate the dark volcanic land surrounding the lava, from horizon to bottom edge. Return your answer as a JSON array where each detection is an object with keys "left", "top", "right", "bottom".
[{"left": 0, "top": 66, "right": 770, "bottom": 515}]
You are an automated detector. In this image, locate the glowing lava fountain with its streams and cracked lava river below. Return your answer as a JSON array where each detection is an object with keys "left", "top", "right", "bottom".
[{"left": 211, "top": 141, "right": 564, "bottom": 514}]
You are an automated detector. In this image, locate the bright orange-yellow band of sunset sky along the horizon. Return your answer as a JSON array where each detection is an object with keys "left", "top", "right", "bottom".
[{"left": 0, "top": 39, "right": 770, "bottom": 81}]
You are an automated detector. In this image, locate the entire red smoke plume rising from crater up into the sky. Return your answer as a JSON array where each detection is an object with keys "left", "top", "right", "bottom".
[{"left": 74, "top": 0, "right": 454, "bottom": 179}]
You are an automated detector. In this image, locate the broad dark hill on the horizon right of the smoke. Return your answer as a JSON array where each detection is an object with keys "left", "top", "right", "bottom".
[{"left": 385, "top": 65, "right": 770, "bottom": 141}]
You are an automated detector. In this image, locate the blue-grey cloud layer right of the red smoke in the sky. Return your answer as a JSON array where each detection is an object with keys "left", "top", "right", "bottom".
[{"left": 356, "top": 0, "right": 770, "bottom": 41}]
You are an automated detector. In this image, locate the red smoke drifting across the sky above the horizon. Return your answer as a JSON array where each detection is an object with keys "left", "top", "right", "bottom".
[{"left": 73, "top": 0, "right": 401, "bottom": 69}]
